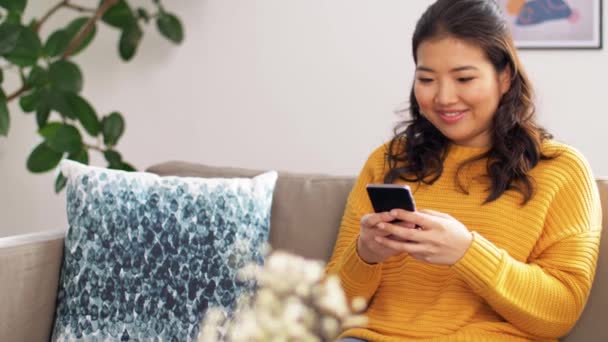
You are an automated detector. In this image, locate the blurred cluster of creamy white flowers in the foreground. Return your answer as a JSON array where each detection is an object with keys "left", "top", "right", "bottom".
[{"left": 199, "top": 251, "right": 367, "bottom": 342}]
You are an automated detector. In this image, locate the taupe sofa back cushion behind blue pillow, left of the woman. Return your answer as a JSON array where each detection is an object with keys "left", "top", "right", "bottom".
[{"left": 148, "top": 162, "right": 354, "bottom": 261}]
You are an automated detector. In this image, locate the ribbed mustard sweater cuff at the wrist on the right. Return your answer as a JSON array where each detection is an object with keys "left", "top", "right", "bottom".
[{"left": 452, "top": 232, "right": 504, "bottom": 290}]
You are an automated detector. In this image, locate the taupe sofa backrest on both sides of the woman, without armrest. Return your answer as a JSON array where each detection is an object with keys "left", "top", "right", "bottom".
[{"left": 148, "top": 162, "right": 608, "bottom": 341}]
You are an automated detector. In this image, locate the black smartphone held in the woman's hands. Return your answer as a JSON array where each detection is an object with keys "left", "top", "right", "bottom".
[{"left": 367, "top": 184, "right": 416, "bottom": 213}]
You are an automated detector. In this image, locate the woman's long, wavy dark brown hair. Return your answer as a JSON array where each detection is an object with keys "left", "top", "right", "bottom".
[{"left": 384, "top": 0, "right": 552, "bottom": 204}]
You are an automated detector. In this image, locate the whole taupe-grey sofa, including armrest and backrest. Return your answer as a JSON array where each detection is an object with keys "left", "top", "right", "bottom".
[{"left": 0, "top": 162, "right": 608, "bottom": 342}]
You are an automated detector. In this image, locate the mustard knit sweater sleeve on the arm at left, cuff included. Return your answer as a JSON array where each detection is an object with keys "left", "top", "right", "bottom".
[{"left": 326, "top": 144, "right": 384, "bottom": 302}]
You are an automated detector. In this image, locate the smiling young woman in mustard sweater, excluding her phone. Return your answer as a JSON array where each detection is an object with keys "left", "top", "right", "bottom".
[{"left": 328, "top": 0, "right": 601, "bottom": 341}]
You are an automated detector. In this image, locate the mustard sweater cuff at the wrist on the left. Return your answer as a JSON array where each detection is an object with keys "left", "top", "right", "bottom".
[{"left": 340, "top": 239, "right": 382, "bottom": 287}]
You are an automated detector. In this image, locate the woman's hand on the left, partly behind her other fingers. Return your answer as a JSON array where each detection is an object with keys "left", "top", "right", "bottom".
[{"left": 357, "top": 213, "right": 409, "bottom": 264}]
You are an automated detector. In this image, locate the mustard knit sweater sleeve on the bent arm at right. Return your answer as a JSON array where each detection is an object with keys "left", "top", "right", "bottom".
[{"left": 453, "top": 148, "right": 602, "bottom": 338}]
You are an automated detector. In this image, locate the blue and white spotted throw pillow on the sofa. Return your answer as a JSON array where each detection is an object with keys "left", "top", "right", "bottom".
[{"left": 53, "top": 160, "right": 277, "bottom": 341}]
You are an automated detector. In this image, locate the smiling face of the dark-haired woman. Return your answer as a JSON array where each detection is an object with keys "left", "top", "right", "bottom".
[{"left": 414, "top": 36, "right": 510, "bottom": 147}]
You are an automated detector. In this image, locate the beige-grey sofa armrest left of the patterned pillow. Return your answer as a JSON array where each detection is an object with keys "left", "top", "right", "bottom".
[{"left": 0, "top": 231, "right": 65, "bottom": 341}]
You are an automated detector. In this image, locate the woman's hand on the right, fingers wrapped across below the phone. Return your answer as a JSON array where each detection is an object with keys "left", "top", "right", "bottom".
[{"left": 376, "top": 209, "right": 473, "bottom": 265}]
